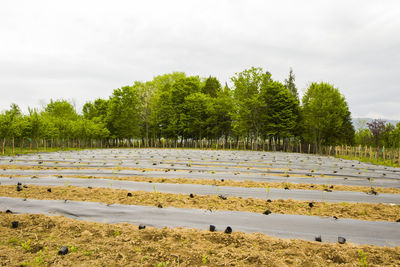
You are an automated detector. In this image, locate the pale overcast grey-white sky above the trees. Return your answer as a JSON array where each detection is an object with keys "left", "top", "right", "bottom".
[{"left": 0, "top": 0, "right": 400, "bottom": 120}]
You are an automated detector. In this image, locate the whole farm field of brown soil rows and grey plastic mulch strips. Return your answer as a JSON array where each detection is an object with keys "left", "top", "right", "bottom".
[{"left": 0, "top": 149, "right": 400, "bottom": 266}]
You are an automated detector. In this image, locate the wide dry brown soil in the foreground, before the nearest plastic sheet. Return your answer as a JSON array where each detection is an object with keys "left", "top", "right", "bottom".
[{"left": 0, "top": 212, "right": 400, "bottom": 266}]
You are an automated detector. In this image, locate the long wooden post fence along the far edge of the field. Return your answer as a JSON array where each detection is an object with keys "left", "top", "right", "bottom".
[{"left": 2, "top": 138, "right": 400, "bottom": 167}]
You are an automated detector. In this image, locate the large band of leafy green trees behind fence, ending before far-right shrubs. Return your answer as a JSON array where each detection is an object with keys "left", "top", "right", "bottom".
[{"left": 0, "top": 67, "right": 355, "bottom": 155}]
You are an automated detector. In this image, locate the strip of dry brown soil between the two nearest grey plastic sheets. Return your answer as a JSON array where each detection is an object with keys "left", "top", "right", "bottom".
[{"left": 0, "top": 185, "right": 400, "bottom": 221}]
